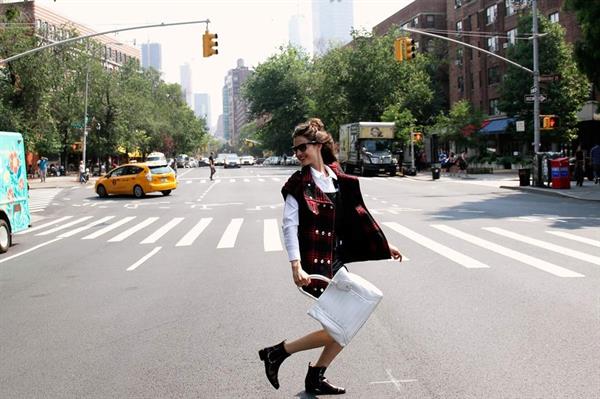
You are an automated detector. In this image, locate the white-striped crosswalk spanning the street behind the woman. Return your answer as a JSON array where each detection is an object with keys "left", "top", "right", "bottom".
[{"left": 18, "top": 216, "right": 600, "bottom": 278}]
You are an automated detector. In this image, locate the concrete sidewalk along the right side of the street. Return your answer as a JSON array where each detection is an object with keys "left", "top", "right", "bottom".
[{"left": 405, "top": 170, "right": 600, "bottom": 201}]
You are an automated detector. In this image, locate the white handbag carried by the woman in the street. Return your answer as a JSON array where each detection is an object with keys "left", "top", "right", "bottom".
[{"left": 298, "top": 267, "right": 383, "bottom": 346}]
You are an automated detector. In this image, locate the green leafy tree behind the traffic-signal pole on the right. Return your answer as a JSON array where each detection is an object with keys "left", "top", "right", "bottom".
[{"left": 499, "top": 15, "right": 590, "bottom": 143}]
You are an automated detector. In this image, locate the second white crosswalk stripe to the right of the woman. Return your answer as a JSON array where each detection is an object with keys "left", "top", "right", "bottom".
[{"left": 431, "top": 224, "right": 585, "bottom": 277}]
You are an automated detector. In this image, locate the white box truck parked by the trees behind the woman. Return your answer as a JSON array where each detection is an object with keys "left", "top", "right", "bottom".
[{"left": 339, "top": 122, "right": 398, "bottom": 176}]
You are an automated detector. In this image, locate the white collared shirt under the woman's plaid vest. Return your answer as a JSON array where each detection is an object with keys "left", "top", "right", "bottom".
[{"left": 283, "top": 165, "right": 337, "bottom": 262}]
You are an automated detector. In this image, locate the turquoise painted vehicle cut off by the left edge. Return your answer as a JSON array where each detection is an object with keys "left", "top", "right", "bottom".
[{"left": 0, "top": 132, "right": 31, "bottom": 253}]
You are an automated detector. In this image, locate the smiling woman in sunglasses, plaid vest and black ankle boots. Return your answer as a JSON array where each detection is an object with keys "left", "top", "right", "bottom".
[{"left": 259, "top": 118, "right": 402, "bottom": 395}]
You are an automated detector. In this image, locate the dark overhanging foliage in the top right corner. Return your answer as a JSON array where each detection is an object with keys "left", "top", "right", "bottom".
[{"left": 564, "top": 0, "right": 600, "bottom": 87}]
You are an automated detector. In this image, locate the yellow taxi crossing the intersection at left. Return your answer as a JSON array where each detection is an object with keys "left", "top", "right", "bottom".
[{"left": 95, "top": 163, "right": 177, "bottom": 198}]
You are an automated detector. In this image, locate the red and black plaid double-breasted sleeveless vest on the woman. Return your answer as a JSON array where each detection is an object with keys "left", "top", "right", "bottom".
[{"left": 281, "top": 164, "right": 390, "bottom": 292}]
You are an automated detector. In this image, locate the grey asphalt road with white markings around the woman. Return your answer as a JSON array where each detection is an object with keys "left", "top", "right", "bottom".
[{"left": 0, "top": 167, "right": 600, "bottom": 398}]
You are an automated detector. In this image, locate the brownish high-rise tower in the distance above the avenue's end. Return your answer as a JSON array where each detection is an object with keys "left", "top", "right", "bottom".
[{"left": 223, "top": 59, "right": 251, "bottom": 145}]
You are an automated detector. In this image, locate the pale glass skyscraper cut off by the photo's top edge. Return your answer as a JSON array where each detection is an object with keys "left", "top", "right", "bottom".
[{"left": 312, "top": 0, "right": 354, "bottom": 54}]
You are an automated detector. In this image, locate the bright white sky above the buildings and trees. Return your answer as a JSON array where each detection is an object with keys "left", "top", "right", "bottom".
[{"left": 36, "top": 0, "right": 412, "bottom": 130}]
